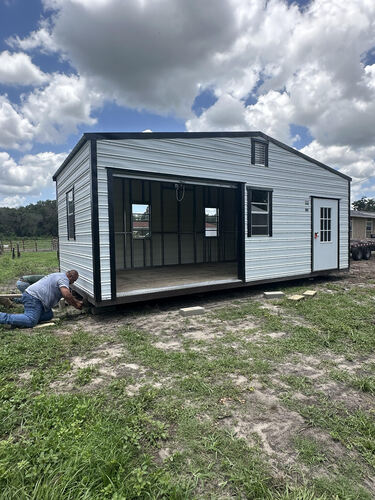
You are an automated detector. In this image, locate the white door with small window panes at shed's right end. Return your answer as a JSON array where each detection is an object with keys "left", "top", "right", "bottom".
[{"left": 312, "top": 198, "right": 339, "bottom": 271}]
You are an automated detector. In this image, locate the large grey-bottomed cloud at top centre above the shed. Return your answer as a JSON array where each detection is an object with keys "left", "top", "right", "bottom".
[{"left": 13, "top": 0, "right": 238, "bottom": 116}]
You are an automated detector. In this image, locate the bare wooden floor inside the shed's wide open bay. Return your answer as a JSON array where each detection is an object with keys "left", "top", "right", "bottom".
[{"left": 117, "top": 262, "right": 238, "bottom": 297}]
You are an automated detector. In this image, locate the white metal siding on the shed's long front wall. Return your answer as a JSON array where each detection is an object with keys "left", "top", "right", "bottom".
[{"left": 97, "top": 137, "right": 348, "bottom": 291}]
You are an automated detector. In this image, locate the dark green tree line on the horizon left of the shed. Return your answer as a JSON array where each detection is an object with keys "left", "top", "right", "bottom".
[{"left": 0, "top": 200, "right": 57, "bottom": 239}]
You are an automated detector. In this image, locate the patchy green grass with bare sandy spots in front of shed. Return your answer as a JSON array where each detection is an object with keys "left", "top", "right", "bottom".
[{"left": 0, "top": 253, "right": 375, "bottom": 500}]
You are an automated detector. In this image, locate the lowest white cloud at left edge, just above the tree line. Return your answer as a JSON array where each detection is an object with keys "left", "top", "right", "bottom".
[{"left": 0, "top": 152, "right": 66, "bottom": 197}]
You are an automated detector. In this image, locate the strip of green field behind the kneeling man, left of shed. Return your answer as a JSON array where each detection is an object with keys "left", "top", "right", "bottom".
[{"left": 0, "top": 252, "right": 59, "bottom": 288}]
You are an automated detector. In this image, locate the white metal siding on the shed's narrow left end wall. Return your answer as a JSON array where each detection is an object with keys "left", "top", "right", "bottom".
[{"left": 56, "top": 143, "right": 94, "bottom": 297}]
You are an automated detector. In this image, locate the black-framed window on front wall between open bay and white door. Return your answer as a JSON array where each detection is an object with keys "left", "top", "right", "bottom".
[{"left": 247, "top": 189, "right": 272, "bottom": 236}]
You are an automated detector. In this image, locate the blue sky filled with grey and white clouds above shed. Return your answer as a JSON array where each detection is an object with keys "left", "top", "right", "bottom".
[{"left": 0, "top": 0, "right": 375, "bottom": 207}]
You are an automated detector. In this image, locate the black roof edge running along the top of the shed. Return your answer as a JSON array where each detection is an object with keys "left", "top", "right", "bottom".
[{"left": 53, "top": 131, "right": 352, "bottom": 181}]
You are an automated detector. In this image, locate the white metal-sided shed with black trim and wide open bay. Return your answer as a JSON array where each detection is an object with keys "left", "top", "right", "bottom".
[{"left": 53, "top": 132, "right": 351, "bottom": 306}]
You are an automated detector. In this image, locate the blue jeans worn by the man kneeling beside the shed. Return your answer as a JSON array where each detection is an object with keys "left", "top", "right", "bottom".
[{"left": 0, "top": 292, "right": 53, "bottom": 328}]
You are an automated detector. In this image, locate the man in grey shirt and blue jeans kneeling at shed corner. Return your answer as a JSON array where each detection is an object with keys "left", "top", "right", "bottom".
[{"left": 0, "top": 270, "right": 83, "bottom": 328}]
